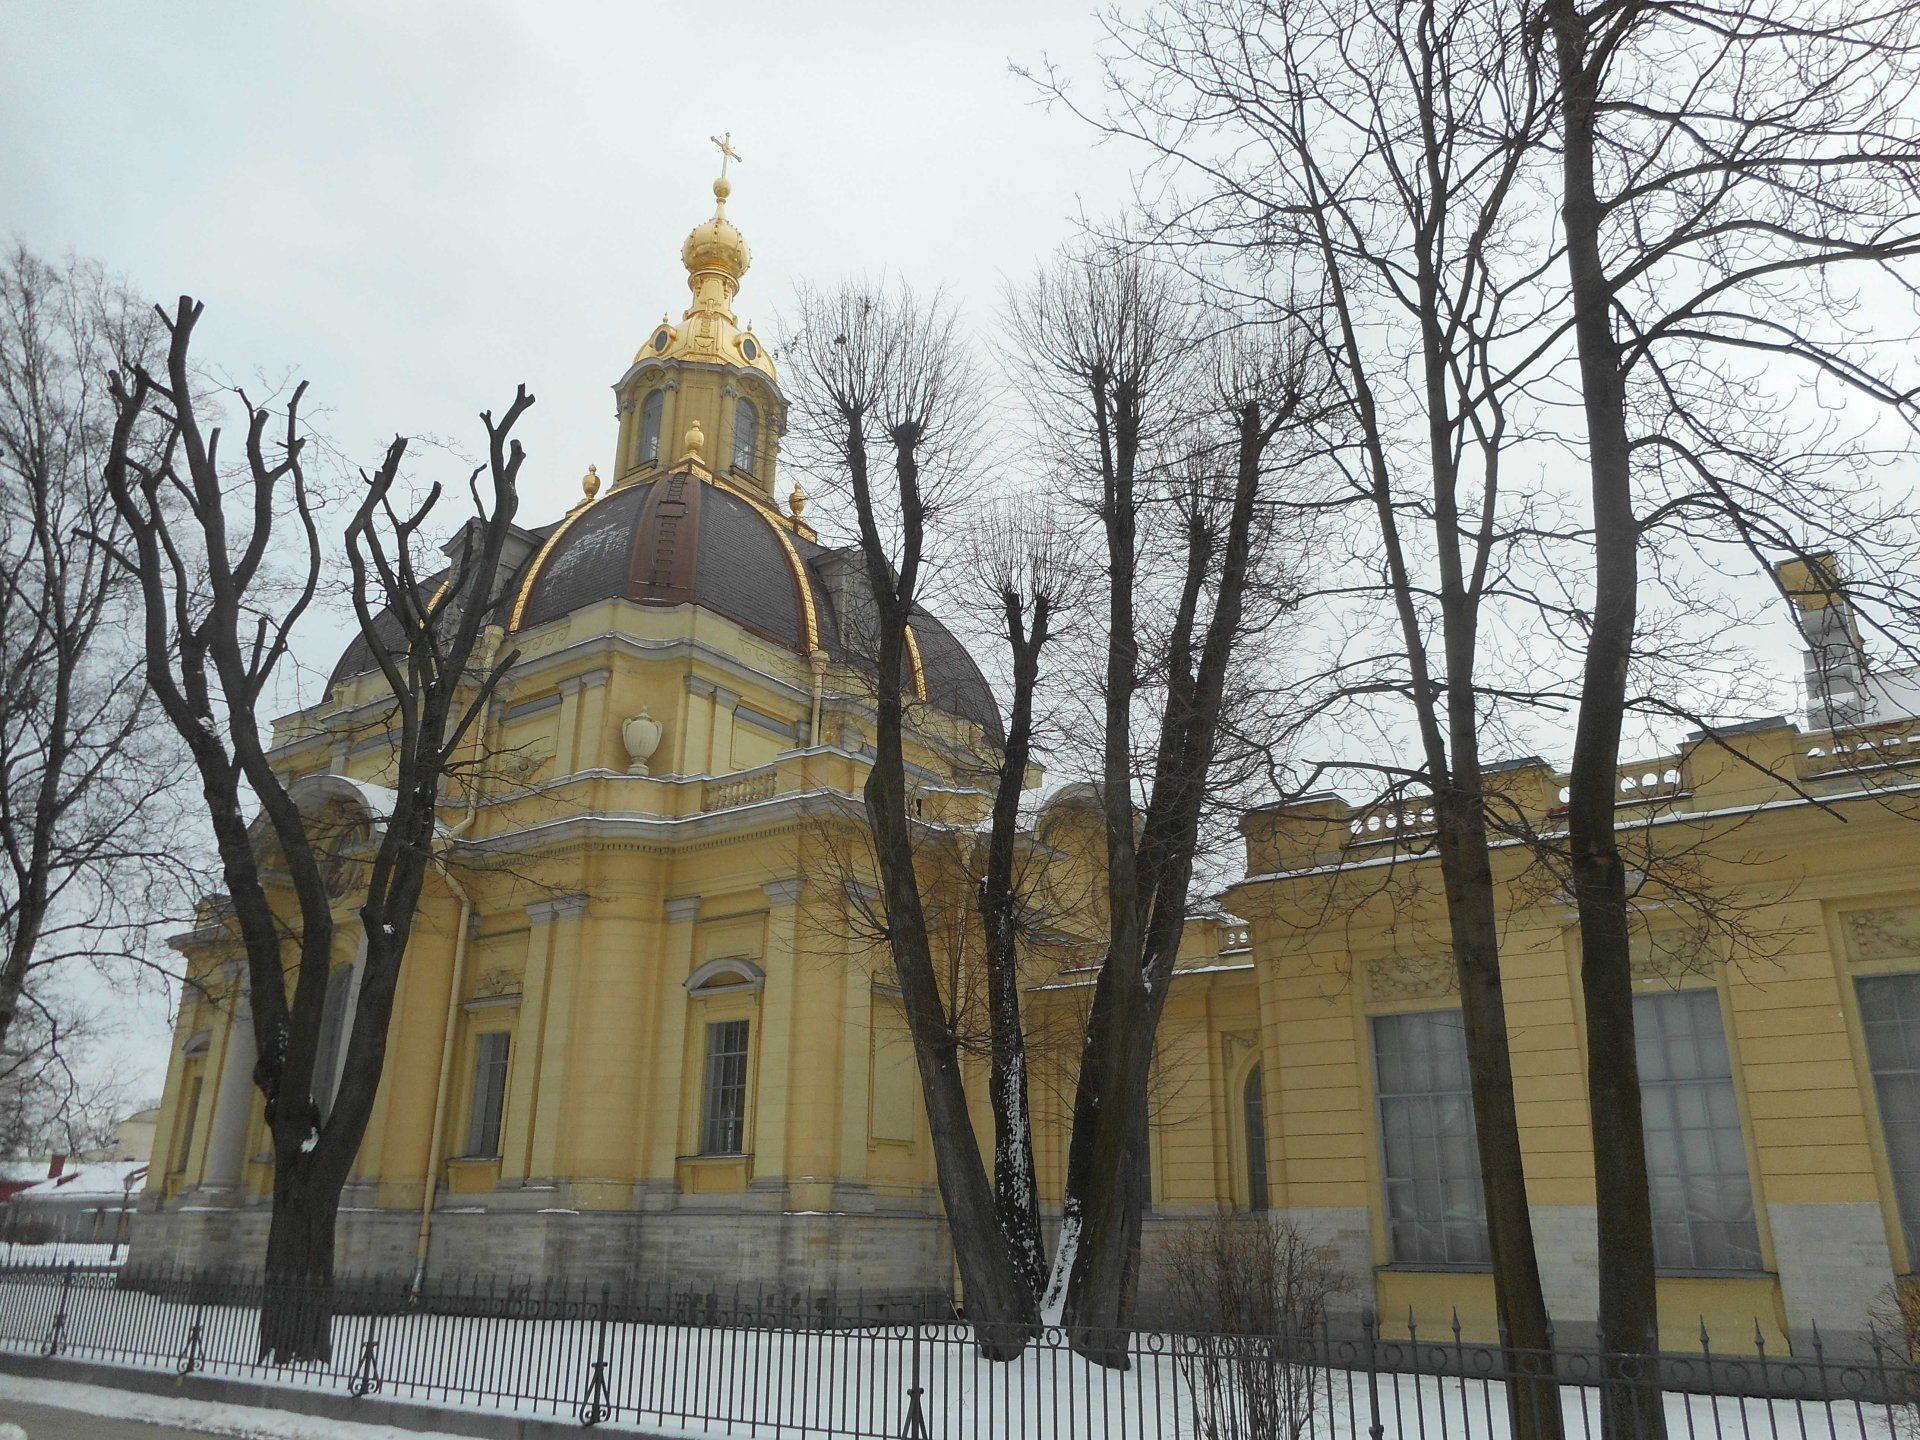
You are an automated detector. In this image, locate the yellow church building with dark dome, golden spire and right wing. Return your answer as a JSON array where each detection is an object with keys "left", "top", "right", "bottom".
[{"left": 142, "top": 163, "right": 1920, "bottom": 1354}]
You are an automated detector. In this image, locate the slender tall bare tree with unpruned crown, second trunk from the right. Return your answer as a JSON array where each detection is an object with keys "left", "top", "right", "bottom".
[{"left": 1043, "top": 0, "right": 1565, "bottom": 1434}]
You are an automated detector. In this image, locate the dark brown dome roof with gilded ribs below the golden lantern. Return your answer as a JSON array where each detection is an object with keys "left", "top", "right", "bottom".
[{"left": 328, "top": 470, "right": 1004, "bottom": 741}]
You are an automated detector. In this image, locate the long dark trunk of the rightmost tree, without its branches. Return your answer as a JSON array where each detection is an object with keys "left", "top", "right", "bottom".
[{"left": 1546, "top": 0, "right": 1667, "bottom": 1440}]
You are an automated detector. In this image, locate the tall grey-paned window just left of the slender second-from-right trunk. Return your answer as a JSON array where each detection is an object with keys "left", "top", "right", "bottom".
[{"left": 1373, "top": 1010, "right": 1490, "bottom": 1265}]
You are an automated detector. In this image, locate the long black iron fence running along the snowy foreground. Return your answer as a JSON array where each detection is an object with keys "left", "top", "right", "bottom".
[{"left": 0, "top": 1265, "right": 1920, "bottom": 1440}]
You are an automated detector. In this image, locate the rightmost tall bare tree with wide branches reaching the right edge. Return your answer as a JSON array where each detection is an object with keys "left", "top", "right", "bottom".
[{"left": 1538, "top": 0, "right": 1920, "bottom": 1436}]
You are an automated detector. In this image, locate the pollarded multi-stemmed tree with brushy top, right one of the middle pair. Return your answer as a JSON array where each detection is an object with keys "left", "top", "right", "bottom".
[{"left": 1012, "top": 255, "right": 1317, "bottom": 1365}]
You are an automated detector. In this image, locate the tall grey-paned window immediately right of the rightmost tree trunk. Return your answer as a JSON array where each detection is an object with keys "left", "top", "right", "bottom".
[{"left": 1634, "top": 991, "right": 1761, "bottom": 1269}]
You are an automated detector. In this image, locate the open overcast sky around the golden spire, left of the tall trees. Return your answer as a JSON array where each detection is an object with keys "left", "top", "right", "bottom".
[{"left": 0, "top": 0, "right": 1131, "bottom": 1092}]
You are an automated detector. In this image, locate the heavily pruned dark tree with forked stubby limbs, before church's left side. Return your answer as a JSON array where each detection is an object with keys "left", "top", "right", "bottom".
[{"left": 106, "top": 296, "right": 534, "bottom": 1361}]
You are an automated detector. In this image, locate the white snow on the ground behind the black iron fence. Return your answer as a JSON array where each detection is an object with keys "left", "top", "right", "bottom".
[{"left": 0, "top": 1275, "right": 1895, "bottom": 1440}]
